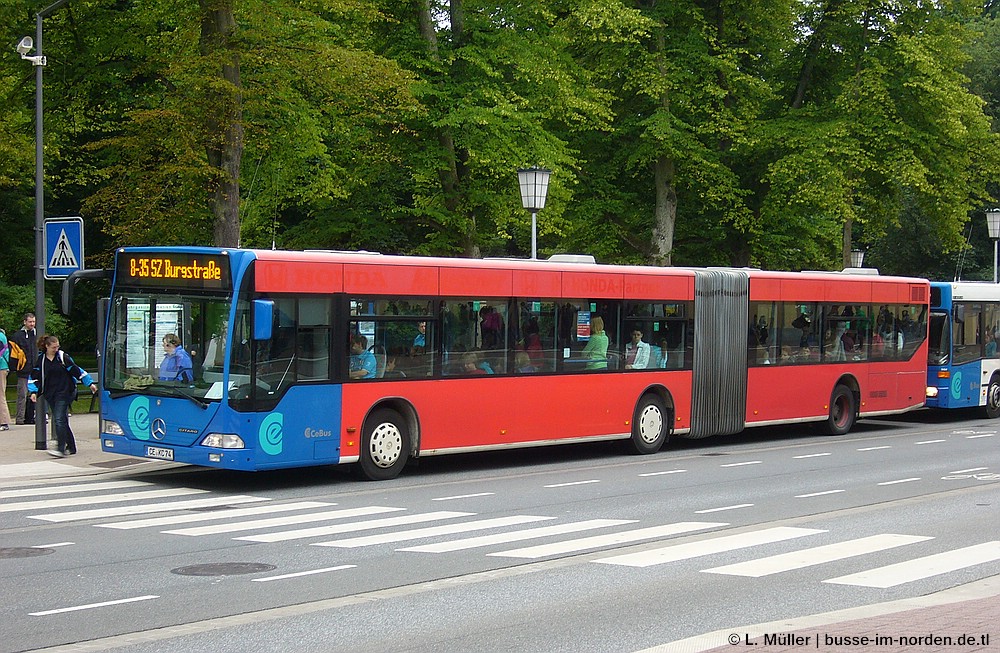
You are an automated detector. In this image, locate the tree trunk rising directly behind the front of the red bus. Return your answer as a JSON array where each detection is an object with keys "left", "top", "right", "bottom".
[{"left": 199, "top": 0, "right": 243, "bottom": 247}]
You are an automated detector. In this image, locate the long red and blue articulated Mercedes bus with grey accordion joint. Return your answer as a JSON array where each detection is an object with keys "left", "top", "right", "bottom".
[{"left": 100, "top": 247, "right": 930, "bottom": 479}]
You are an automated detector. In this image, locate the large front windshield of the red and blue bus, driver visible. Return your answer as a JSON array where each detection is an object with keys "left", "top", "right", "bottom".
[{"left": 102, "top": 290, "right": 232, "bottom": 405}]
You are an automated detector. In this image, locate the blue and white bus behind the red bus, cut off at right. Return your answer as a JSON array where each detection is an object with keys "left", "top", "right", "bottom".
[{"left": 927, "top": 281, "right": 1000, "bottom": 418}]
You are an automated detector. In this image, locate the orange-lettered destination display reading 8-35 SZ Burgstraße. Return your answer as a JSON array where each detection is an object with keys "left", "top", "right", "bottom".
[{"left": 118, "top": 252, "right": 231, "bottom": 289}]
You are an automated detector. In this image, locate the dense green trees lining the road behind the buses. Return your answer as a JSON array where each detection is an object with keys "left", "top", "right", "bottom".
[{"left": 0, "top": 0, "right": 1000, "bottom": 352}]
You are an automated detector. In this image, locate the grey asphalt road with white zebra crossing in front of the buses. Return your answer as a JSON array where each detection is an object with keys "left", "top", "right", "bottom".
[{"left": 0, "top": 411, "right": 1000, "bottom": 653}]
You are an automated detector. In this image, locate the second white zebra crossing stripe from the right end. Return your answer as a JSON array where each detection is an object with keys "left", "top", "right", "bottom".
[{"left": 702, "top": 533, "right": 934, "bottom": 578}]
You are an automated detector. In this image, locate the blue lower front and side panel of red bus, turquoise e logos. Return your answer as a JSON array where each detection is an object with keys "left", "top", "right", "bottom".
[{"left": 101, "top": 385, "right": 341, "bottom": 471}]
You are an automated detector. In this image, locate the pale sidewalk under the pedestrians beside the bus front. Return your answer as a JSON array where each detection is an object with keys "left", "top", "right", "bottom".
[{"left": 0, "top": 413, "right": 162, "bottom": 482}]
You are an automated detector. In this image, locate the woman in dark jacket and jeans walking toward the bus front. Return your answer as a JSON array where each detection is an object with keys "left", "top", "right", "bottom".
[{"left": 28, "top": 334, "right": 97, "bottom": 458}]
